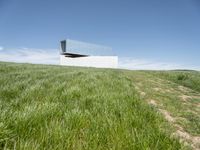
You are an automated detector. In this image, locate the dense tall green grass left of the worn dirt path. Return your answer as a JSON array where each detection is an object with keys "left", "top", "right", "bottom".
[{"left": 0, "top": 62, "right": 191, "bottom": 150}]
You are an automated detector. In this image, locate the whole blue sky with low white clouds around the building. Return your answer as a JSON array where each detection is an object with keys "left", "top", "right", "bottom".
[{"left": 0, "top": 0, "right": 200, "bottom": 70}]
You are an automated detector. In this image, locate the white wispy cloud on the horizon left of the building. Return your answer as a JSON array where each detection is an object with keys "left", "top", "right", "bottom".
[{"left": 0, "top": 48, "right": 59, "bottom": 64}]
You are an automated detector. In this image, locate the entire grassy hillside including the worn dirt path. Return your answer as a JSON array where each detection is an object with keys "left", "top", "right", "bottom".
[{"left": 0, "top": 62, "right": 200, "bottom": 150}]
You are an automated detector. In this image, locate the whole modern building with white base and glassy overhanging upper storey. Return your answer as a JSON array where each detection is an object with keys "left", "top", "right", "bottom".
[{"left": 60, "top": 39, "right": 118, "bottom": 68}]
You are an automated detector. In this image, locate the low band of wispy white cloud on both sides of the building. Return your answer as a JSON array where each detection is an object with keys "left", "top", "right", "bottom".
[{"left": 0, "top": 47, "right": 200, "bottom": 70}]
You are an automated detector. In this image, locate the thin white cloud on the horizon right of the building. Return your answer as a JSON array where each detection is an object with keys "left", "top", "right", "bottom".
[{"left": 119, "top": 57, "right": 200, "bottom": 70}]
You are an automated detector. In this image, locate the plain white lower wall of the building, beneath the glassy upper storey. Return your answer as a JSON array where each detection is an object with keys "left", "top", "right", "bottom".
[{"left": 60, "top": 55, "right": 118, "bottom": 68}]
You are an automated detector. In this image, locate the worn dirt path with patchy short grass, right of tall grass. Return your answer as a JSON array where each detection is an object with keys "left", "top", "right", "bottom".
[{"left": 127, "top": 72, "right": 200, "bottom": 150}]
